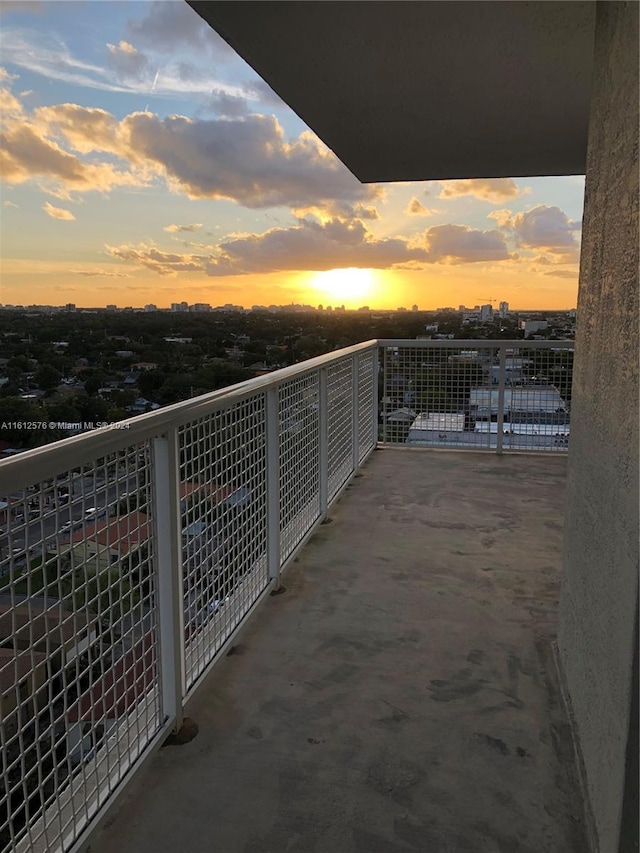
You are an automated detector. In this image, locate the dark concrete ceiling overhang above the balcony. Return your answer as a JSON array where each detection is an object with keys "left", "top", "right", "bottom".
[{"left": 189, "top": 0, "right": 596, "bottom": 182}]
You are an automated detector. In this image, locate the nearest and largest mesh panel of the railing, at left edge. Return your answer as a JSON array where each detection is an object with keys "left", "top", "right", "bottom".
[{"left": 0, "top": 442, "right": 162, "bottom": 852}]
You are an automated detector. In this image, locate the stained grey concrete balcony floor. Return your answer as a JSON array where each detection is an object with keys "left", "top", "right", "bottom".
[{"left": 91, "top": 450, "right": 588, "bottom": 853}]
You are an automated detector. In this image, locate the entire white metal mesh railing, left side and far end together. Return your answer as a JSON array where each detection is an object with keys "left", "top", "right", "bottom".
[{"left": 0, "top": 340, "right": 572, "bottom": 853}]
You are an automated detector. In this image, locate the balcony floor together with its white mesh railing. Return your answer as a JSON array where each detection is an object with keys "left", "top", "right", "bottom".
[{"left": 0, "top": 341, "right": 586, "bottom": 853}]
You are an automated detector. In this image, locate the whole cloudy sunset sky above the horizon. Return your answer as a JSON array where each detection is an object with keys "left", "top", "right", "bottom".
[{"left": 0, "top": 0, "right": 584, "bottom": 309}]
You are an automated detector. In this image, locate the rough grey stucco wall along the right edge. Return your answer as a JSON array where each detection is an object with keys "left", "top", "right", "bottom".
[{"left": 558, "top": 2, "right": 638, "bottom": 853}]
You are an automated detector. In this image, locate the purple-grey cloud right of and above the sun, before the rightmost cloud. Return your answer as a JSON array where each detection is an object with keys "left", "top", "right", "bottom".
[{"left": 425, "top": 225, "right": 513, "bottom": 264}]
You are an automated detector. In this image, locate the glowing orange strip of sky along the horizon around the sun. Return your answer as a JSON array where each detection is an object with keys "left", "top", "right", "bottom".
[{"left": 0, "top": 258, "right": 578, "bottom": 311}]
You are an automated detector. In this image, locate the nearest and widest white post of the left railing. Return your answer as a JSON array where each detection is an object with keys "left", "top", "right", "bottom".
[{"left": 152, "top": 429, "right": 186, "bottom": 731}]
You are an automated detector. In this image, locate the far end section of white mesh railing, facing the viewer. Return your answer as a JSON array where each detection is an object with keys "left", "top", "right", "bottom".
[{"left": 378, "top": 340, "right": 574, "bottom": 453}]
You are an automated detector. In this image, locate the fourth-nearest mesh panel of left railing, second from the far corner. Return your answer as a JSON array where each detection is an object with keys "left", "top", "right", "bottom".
[{"left": 327, "top": 358, "right": 353, "bottom": 501}]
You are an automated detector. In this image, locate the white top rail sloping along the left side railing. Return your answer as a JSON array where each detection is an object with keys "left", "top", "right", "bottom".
[{"left": 0, "top": 339, "right": 378, "bottom": 494}]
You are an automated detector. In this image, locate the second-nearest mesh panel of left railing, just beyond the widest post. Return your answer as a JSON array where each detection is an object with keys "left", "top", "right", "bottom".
[{"left": 179, "top": 393, "right": 269, "bottom": 688}]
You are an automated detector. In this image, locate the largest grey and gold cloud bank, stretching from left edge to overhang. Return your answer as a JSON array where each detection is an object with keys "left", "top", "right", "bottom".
[{"left": 0, "top": 82, "right": 384, "bottom": 209}]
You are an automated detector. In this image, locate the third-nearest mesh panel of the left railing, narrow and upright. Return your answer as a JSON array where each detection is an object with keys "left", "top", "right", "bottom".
[{"left": 278, "top": 371, "right": 320, "bottom": 563}]
